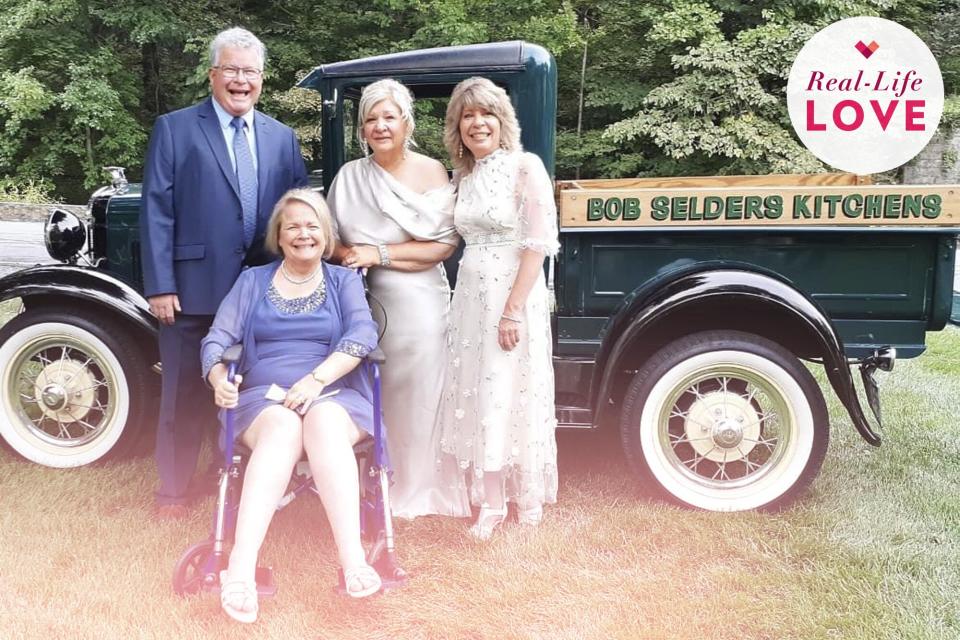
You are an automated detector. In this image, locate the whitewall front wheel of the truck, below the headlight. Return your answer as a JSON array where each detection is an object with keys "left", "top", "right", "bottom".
[{"left": 0, "top": 309, "right": 149, "bottom": 468}]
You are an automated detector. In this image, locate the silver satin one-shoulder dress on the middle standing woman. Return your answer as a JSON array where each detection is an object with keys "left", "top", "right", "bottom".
[{"left": 327, "top": 158, "right": 470, "bottom": 518}]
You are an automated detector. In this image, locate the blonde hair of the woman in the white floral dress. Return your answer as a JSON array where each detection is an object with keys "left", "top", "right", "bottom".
[{"left": 443, "top": 78, "right": 523, "bottom": 173}]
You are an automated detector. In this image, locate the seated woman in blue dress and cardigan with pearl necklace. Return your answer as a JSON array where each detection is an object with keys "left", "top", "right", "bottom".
[{"left": 201, "top": 189, "right": 381, "bottom": 622}]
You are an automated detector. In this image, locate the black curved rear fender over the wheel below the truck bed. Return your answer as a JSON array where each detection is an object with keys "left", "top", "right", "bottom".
[{"left": 592, "top": 268, "right": 880, "bottom": 446}]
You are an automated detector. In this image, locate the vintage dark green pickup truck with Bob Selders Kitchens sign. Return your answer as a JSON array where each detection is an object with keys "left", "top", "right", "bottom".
[{"left": 0, "top": 42, "right": 960, "bottom": 511}]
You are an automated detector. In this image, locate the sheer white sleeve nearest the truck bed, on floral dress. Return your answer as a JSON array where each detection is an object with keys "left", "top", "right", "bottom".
[{"left": 517, "top": 153, "right": 560, "bottom": 257}]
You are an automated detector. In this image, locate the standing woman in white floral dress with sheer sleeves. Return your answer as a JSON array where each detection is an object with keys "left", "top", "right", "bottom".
[{"left": 440, "top": 78, "right": 559, "bottom": 539}]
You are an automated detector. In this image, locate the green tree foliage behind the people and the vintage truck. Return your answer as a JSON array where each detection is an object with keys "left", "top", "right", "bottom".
[{"left": 0, "top": 0, "right": 960, "bottom": 201}]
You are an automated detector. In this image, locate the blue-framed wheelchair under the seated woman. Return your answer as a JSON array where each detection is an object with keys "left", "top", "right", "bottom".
[{"left": 173, "top": 345, "right": 407, "bottom": 597}]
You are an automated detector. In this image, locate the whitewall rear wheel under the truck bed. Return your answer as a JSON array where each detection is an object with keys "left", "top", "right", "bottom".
[{"left": 620, "top": 331, "right": 829, "bottom": 511}]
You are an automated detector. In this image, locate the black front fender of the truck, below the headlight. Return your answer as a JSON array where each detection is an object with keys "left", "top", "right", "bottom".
[{"left": 0, "top": 265, "right": 158, "bottom": 339}]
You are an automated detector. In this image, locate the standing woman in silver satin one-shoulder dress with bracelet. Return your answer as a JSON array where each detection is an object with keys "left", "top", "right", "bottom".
[{"left": 327, "top": 80, "right": 470, "bottom": 518}]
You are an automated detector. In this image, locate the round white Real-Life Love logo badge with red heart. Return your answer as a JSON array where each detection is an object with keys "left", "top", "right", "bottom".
[{"left": 787, "top": 17, "right": 943, "bottom": 174}]
